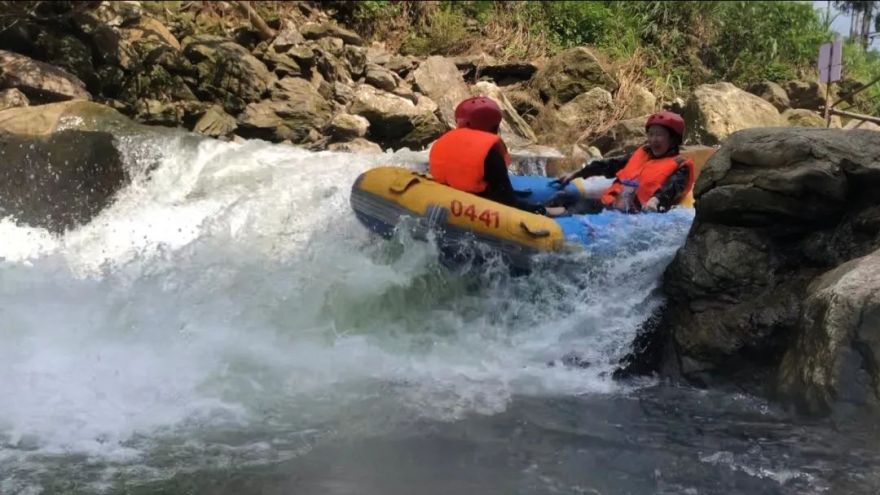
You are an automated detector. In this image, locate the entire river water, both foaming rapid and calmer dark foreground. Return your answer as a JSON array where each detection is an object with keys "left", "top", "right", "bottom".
[{"left": 0, "top": 134, "right": 880, "bottom": 495}]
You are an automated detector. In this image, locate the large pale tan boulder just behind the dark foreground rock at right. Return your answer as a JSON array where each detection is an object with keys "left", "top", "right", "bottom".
[{"left": 684, "top": 82, "right": 786, "bottom": 145}]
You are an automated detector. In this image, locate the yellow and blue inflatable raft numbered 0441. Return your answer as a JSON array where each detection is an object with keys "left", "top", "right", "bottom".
[{"left": 351, "top": 147, "right": 711, "bottom": 270}]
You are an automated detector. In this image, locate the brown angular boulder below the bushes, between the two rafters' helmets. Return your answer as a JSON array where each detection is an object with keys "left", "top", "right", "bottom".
[{"left": 532, "top": 47, "right": 618, "bottom": 104}]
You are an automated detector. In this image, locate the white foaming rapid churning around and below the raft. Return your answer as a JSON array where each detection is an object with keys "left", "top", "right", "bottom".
[{"left": 0, "top": 133, "right": 692, "bottom": 493}]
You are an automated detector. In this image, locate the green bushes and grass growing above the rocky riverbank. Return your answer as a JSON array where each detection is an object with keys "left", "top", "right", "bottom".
[{"left": 337, "top": 1, "right": 880, "bottom": 113}]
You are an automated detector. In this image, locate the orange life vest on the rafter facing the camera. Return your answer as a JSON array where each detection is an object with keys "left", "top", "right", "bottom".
[{"left": 601, "top": 146, "right": 696, "bottom": 210}]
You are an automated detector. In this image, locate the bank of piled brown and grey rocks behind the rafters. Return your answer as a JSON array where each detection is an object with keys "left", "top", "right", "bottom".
[{"left": 0, "top": 2, "right": 872, "bottom": 157}]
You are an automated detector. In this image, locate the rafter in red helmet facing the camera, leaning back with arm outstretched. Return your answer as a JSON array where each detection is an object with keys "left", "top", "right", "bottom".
[{"left": 547, "top": 112, "right": 696, "bottom": 214}]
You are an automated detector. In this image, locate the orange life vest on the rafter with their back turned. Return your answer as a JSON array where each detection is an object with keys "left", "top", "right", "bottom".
[{"left": 428, "top": 127, "right": 510, "bottom": 194}]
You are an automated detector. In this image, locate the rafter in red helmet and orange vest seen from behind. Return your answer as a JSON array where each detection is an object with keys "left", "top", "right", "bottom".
[{"left": 428, "top": 96, "right": 545, "bottom": 214}]
